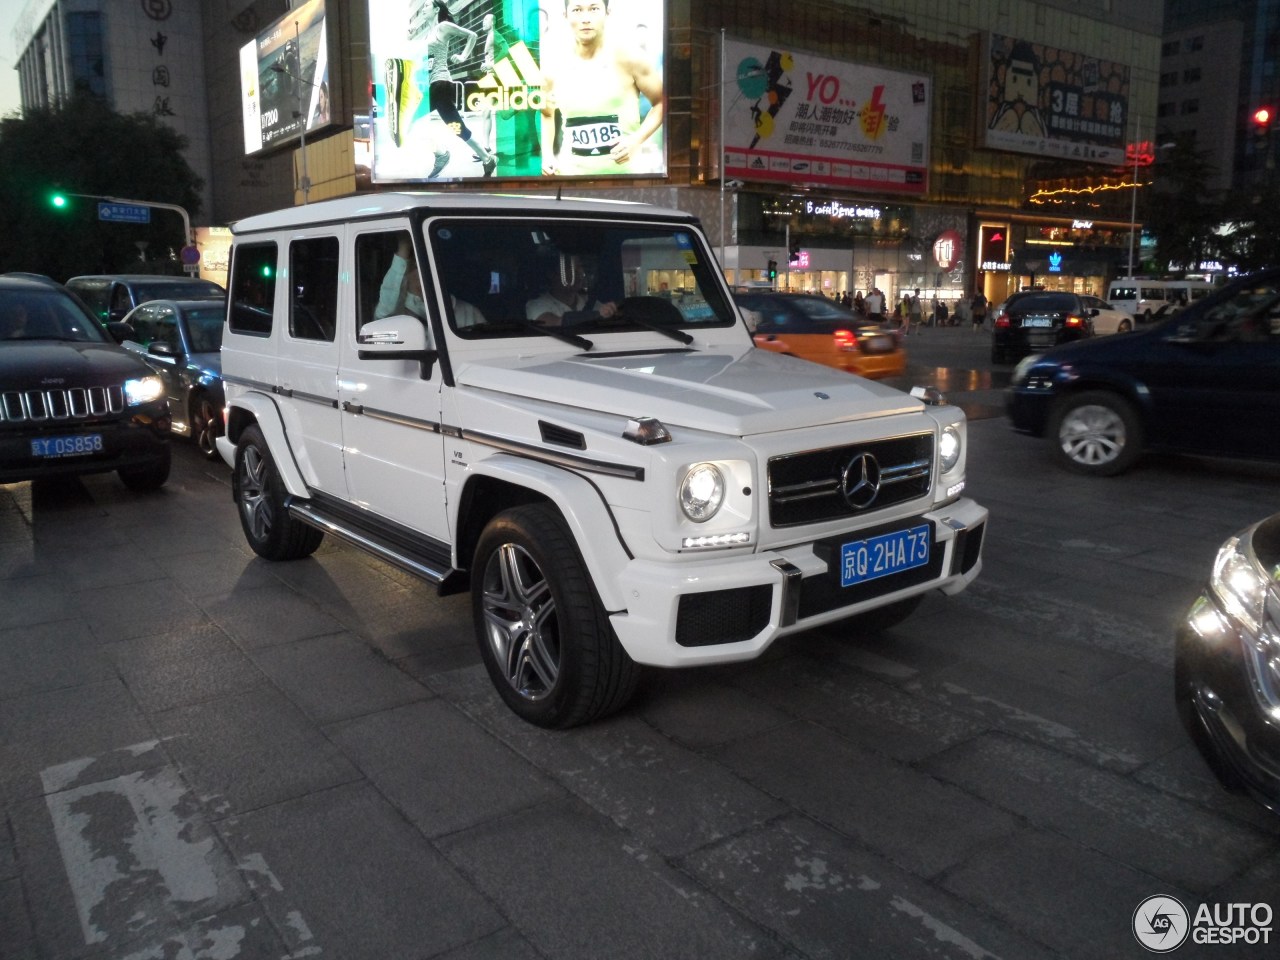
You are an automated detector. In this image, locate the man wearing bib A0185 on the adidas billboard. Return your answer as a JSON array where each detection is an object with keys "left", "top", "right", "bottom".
[{"left": 541, "top": 0, "right": 666, "bottom": 177}]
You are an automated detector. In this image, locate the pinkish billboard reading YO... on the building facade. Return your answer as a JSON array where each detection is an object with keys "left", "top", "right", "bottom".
[{"left": 721, "top": 40, "right": 932, "bottom": 195}]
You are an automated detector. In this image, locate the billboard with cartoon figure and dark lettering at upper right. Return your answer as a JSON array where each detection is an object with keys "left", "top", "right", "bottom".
[{"left": 982, "top": 33, "right": 1129, "bottom": 165}]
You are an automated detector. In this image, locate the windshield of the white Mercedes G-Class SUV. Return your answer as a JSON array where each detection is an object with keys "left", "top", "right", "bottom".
[{"left": 428, "top": 216, "right": 737, "bottom": 349}]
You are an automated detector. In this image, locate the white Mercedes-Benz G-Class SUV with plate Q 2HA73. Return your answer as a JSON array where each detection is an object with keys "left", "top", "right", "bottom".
[{"left": 218, "top": 193, "right": 987, "bottom": 727}]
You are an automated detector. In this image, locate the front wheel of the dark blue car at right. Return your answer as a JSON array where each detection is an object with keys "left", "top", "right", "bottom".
[{"left": 1048, "top": 390, "right": 1142, "bottom": 476}]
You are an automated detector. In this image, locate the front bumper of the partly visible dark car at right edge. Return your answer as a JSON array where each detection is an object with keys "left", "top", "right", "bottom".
[{"left": 1174, "top": 590, "right": 1280, "bottom": 813}]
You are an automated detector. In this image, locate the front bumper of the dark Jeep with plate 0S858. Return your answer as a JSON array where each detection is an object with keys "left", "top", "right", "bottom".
[{"left": 0, "top": 402, "right": 169, "bottom": 484}]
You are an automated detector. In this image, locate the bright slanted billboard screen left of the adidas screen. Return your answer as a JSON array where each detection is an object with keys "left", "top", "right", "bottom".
[{"left": 239, "top": 0, "right": 330, "bottom": 154}]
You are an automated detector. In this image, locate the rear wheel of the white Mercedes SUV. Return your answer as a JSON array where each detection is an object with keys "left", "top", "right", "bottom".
[{"left": 232, "top": 426, "right": 324, "bottom": 561}]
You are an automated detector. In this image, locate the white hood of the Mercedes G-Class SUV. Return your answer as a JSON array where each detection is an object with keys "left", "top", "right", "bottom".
[{"left": 454, "top": 347, "right": 923, "bottom": 436}]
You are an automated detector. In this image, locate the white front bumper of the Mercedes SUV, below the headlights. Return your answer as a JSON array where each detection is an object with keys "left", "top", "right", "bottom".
[{"left": 611, "top": 498, "right": 988, "bottom": 667}]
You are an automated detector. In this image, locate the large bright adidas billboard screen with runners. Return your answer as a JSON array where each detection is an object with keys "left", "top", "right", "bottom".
[{"left": 369, "top": 0, "right": 667, "bottom": 183}]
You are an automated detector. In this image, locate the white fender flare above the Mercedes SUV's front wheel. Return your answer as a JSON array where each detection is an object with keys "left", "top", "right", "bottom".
[{"left": 456, "top": 453, "right": 631, "bottom": 612}]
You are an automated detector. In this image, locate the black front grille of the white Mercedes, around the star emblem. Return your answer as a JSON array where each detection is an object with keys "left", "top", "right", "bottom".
[{"left": 769, "top": 434, "right": 933, "bottom": 527}]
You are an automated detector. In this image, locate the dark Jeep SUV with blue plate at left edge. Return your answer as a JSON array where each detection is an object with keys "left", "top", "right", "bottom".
[{"left": 0, "top": 276, "right": 169, "bottom": 490}]
